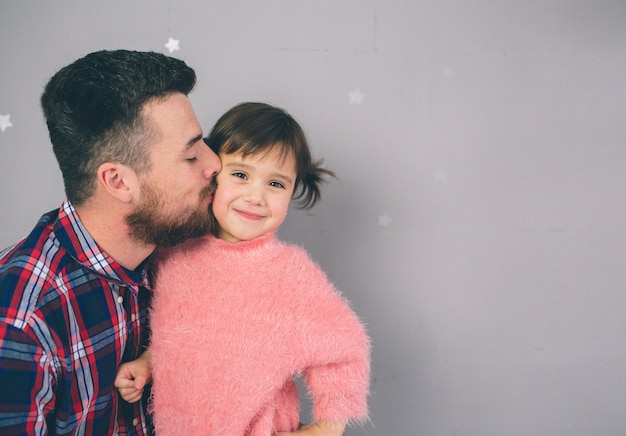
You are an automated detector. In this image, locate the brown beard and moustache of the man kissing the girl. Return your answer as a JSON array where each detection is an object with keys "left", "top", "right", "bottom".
[{"left": 126, "top": 185, "right": 215, "bottom": 246}]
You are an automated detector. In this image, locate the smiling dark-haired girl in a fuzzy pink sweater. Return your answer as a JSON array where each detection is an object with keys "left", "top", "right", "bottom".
[{"left": 151, "top": 103, "right": 370, "bottom": 436}]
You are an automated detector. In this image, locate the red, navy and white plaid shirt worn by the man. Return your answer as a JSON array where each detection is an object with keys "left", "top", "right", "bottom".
[{"left": 0, "top": 201, "right": 152, "bottom": 435}]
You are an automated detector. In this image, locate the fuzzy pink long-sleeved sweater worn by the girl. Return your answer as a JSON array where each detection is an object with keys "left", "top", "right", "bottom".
[{"left": 151, "top": 234, "right": 370, "bottom": 436}]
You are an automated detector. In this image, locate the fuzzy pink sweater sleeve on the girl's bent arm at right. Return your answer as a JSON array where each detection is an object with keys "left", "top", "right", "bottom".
[{"left": 288, "top": 250, "right": 370, "bottom": 423}]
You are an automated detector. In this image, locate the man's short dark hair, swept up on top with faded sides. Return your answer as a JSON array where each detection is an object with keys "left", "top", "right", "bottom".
[{"left": 41, "top": 50, "right": 196, "bottom": 205}]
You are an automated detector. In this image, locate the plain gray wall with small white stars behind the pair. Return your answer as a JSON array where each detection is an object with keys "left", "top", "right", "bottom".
[{"left": 0, "top": 0, "right": 626, "bottom": 435}]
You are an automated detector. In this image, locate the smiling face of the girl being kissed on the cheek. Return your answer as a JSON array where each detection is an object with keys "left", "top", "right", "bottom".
[{"left": 213, "top": 147, "right": 297, "bottom": 242}]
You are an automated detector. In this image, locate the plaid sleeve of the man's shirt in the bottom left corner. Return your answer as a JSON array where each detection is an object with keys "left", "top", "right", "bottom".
[{"left": 0, "top": 321, "right": 55, "bottom": 435}]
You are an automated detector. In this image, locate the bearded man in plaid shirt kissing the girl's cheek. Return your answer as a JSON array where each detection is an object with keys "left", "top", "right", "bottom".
[{"left": 0, "top": 50, "right": 221, "bottom": 435}]
